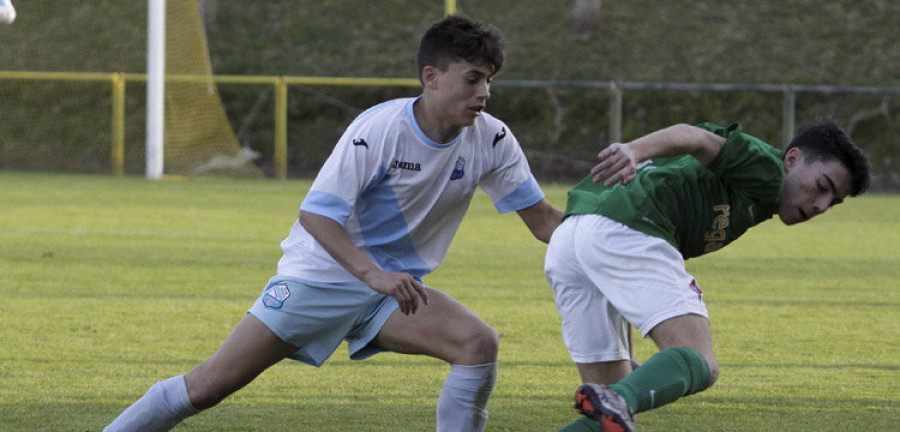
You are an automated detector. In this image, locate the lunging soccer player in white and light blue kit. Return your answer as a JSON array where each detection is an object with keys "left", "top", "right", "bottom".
[{"left": 105, "top": 16, "right": 562, "bottom": 432}]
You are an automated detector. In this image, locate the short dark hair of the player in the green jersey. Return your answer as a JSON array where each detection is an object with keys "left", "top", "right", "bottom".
[{"left": 784, "top": 117, "right": 872, "bottom": 196}]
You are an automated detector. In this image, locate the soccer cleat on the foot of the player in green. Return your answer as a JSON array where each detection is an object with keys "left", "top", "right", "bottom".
[{"left": 575, "top": 383, "right": 634, "bottom": 432}]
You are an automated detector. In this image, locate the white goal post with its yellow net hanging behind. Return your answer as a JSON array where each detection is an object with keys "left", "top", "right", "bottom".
[{"left": 146, "top": 0, "right": 263, "bottom": 180}]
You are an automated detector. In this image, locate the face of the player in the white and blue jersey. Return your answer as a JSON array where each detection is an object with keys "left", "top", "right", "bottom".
[{"left": 425, "top": 61, "right": 494, "bottom": 128}]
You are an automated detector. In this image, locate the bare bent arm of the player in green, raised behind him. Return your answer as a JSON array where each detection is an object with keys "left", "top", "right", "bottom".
[{"left": 591, "top": 123, "right": 725, "bottom": 186}]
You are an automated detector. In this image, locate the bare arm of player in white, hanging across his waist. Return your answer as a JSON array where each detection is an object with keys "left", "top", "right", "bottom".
[{"left": 300, "top": 210, "right": 428, "bottom": 314}]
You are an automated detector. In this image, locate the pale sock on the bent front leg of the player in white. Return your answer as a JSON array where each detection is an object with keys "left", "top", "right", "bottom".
[{"left": 437, "top": 362, "right": 497, "bottom": 432}]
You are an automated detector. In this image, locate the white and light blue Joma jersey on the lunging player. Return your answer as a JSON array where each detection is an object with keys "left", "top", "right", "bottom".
[{"left": 278, "top": 98, "right": 544, "bottom": 283}]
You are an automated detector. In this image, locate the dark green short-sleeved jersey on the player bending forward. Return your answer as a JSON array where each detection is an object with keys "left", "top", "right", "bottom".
[{"left": 565, "top": 123, "right": 784, "bottom": 259}]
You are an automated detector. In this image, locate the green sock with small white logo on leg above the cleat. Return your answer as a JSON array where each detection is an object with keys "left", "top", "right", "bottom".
[{"left": 608, "top": 347, "right": 710, "bottom": 414}]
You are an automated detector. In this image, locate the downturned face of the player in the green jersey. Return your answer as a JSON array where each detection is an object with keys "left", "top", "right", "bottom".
[{"left": 778, "top": 148, "right": 850, "bottom": 225}]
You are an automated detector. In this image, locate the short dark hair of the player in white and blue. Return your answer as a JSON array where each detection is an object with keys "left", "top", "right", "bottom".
[{"left": 416, "top": 14, "right": 506, "bottom": 81}]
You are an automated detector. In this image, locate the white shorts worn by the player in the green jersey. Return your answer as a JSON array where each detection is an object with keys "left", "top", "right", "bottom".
[{"left": 544, "top": 214, "right": 709, "bottom": 363}]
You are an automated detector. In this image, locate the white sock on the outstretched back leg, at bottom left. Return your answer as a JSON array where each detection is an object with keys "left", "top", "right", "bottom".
[{"left": 103, "top": 375, "right": 200, "bottom": 432}]
